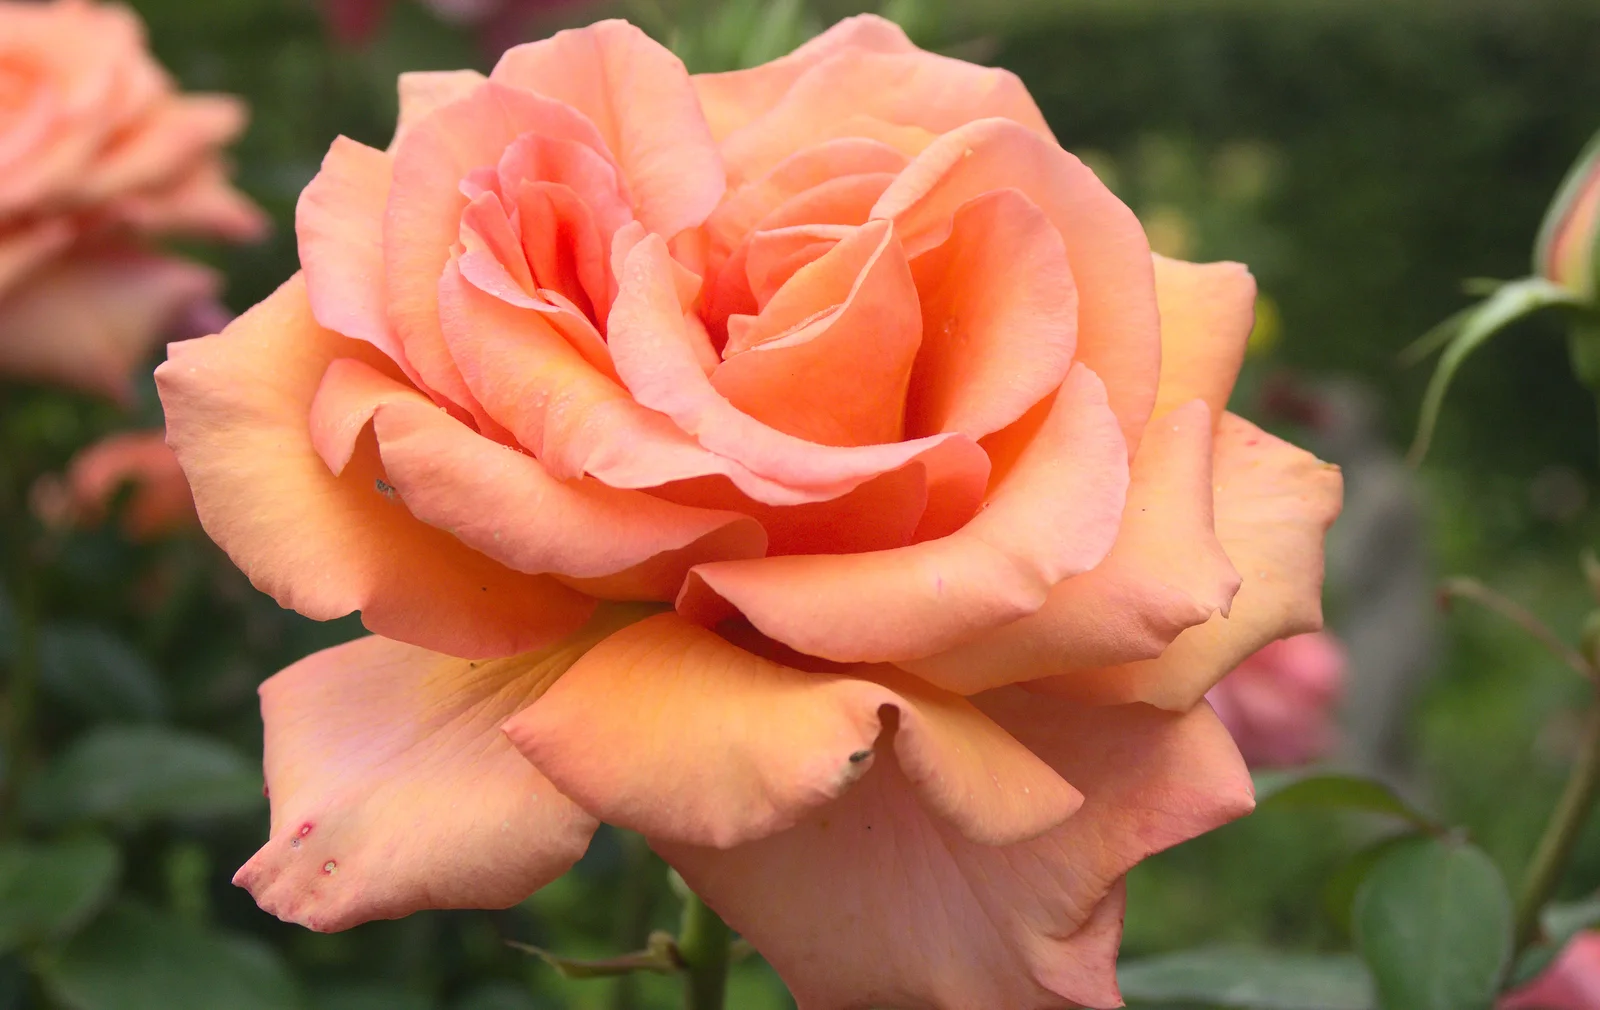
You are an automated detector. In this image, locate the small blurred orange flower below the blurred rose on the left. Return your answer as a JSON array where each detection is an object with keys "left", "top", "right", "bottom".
[{"left": 32, "top": 431, "right": 198, "bottom": 541}]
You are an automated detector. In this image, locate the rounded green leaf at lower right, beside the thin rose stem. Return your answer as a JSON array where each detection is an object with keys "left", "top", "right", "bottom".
[{"left": 1352, "top": 839, "right": 1512, "bottom": 1010}]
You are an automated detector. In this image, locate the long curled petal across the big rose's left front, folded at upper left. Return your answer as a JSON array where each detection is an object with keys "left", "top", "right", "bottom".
[{"left": 310, "top": 359, "right": 766, "bottom": 600}]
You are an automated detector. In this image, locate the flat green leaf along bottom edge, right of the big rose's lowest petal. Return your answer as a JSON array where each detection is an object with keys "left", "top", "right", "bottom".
[{"left": 1117, "top": 948, "right": 1374, "bottom": 1010}]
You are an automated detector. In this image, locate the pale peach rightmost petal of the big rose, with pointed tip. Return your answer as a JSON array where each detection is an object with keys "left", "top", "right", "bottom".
[{"left": 1029, "top": 415, "right": 1344, "bottom": 709}]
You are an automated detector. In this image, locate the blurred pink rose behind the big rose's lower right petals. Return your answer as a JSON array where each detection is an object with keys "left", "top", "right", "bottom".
[{"left": 1206, "top": 631, "right": 1344, "bottom": 767}]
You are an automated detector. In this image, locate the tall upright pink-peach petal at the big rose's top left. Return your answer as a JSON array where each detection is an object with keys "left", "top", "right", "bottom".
[{"left": 491, "top": 21, "right": 723, "bottom": 238}]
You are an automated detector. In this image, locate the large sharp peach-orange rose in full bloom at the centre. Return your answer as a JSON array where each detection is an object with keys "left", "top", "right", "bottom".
[{"left": 157, "top": 18, "right": 1339, "bottom": 1008}]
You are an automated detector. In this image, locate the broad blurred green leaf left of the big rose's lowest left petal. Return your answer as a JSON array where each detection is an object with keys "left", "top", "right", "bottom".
[{"left": 22, "top": 727, "right": 262, "bottom": 826}]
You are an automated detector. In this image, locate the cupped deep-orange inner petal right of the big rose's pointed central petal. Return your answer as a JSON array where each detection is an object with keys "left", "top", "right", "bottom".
[{"left": 906, "top": 189, "right": 1078, "bottom": 439}]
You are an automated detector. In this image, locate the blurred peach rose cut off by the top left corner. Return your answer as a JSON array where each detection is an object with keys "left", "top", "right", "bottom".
[{"left": 0, "top": 0, "right": 266, "bottom": 399}]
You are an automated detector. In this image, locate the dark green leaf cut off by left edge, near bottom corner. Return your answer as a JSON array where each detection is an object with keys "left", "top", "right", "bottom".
[{"left": 0, "top": 836, "right": 122, "bottom": 954}]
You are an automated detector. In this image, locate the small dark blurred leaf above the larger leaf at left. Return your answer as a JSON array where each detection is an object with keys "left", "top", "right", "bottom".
[{"left": 38, "top": 623, "right": 166, "bottom": 722}]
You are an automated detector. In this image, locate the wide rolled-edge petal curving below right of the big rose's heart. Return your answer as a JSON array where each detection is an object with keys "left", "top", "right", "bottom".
[{"left": 678, "top": 368, "right": 1128, "bottom": 663}]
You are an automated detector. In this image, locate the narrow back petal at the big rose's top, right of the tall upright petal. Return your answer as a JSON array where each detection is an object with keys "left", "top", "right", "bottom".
[{"left": 693, "top": 14, "right": 917, "bottom": 141}]
